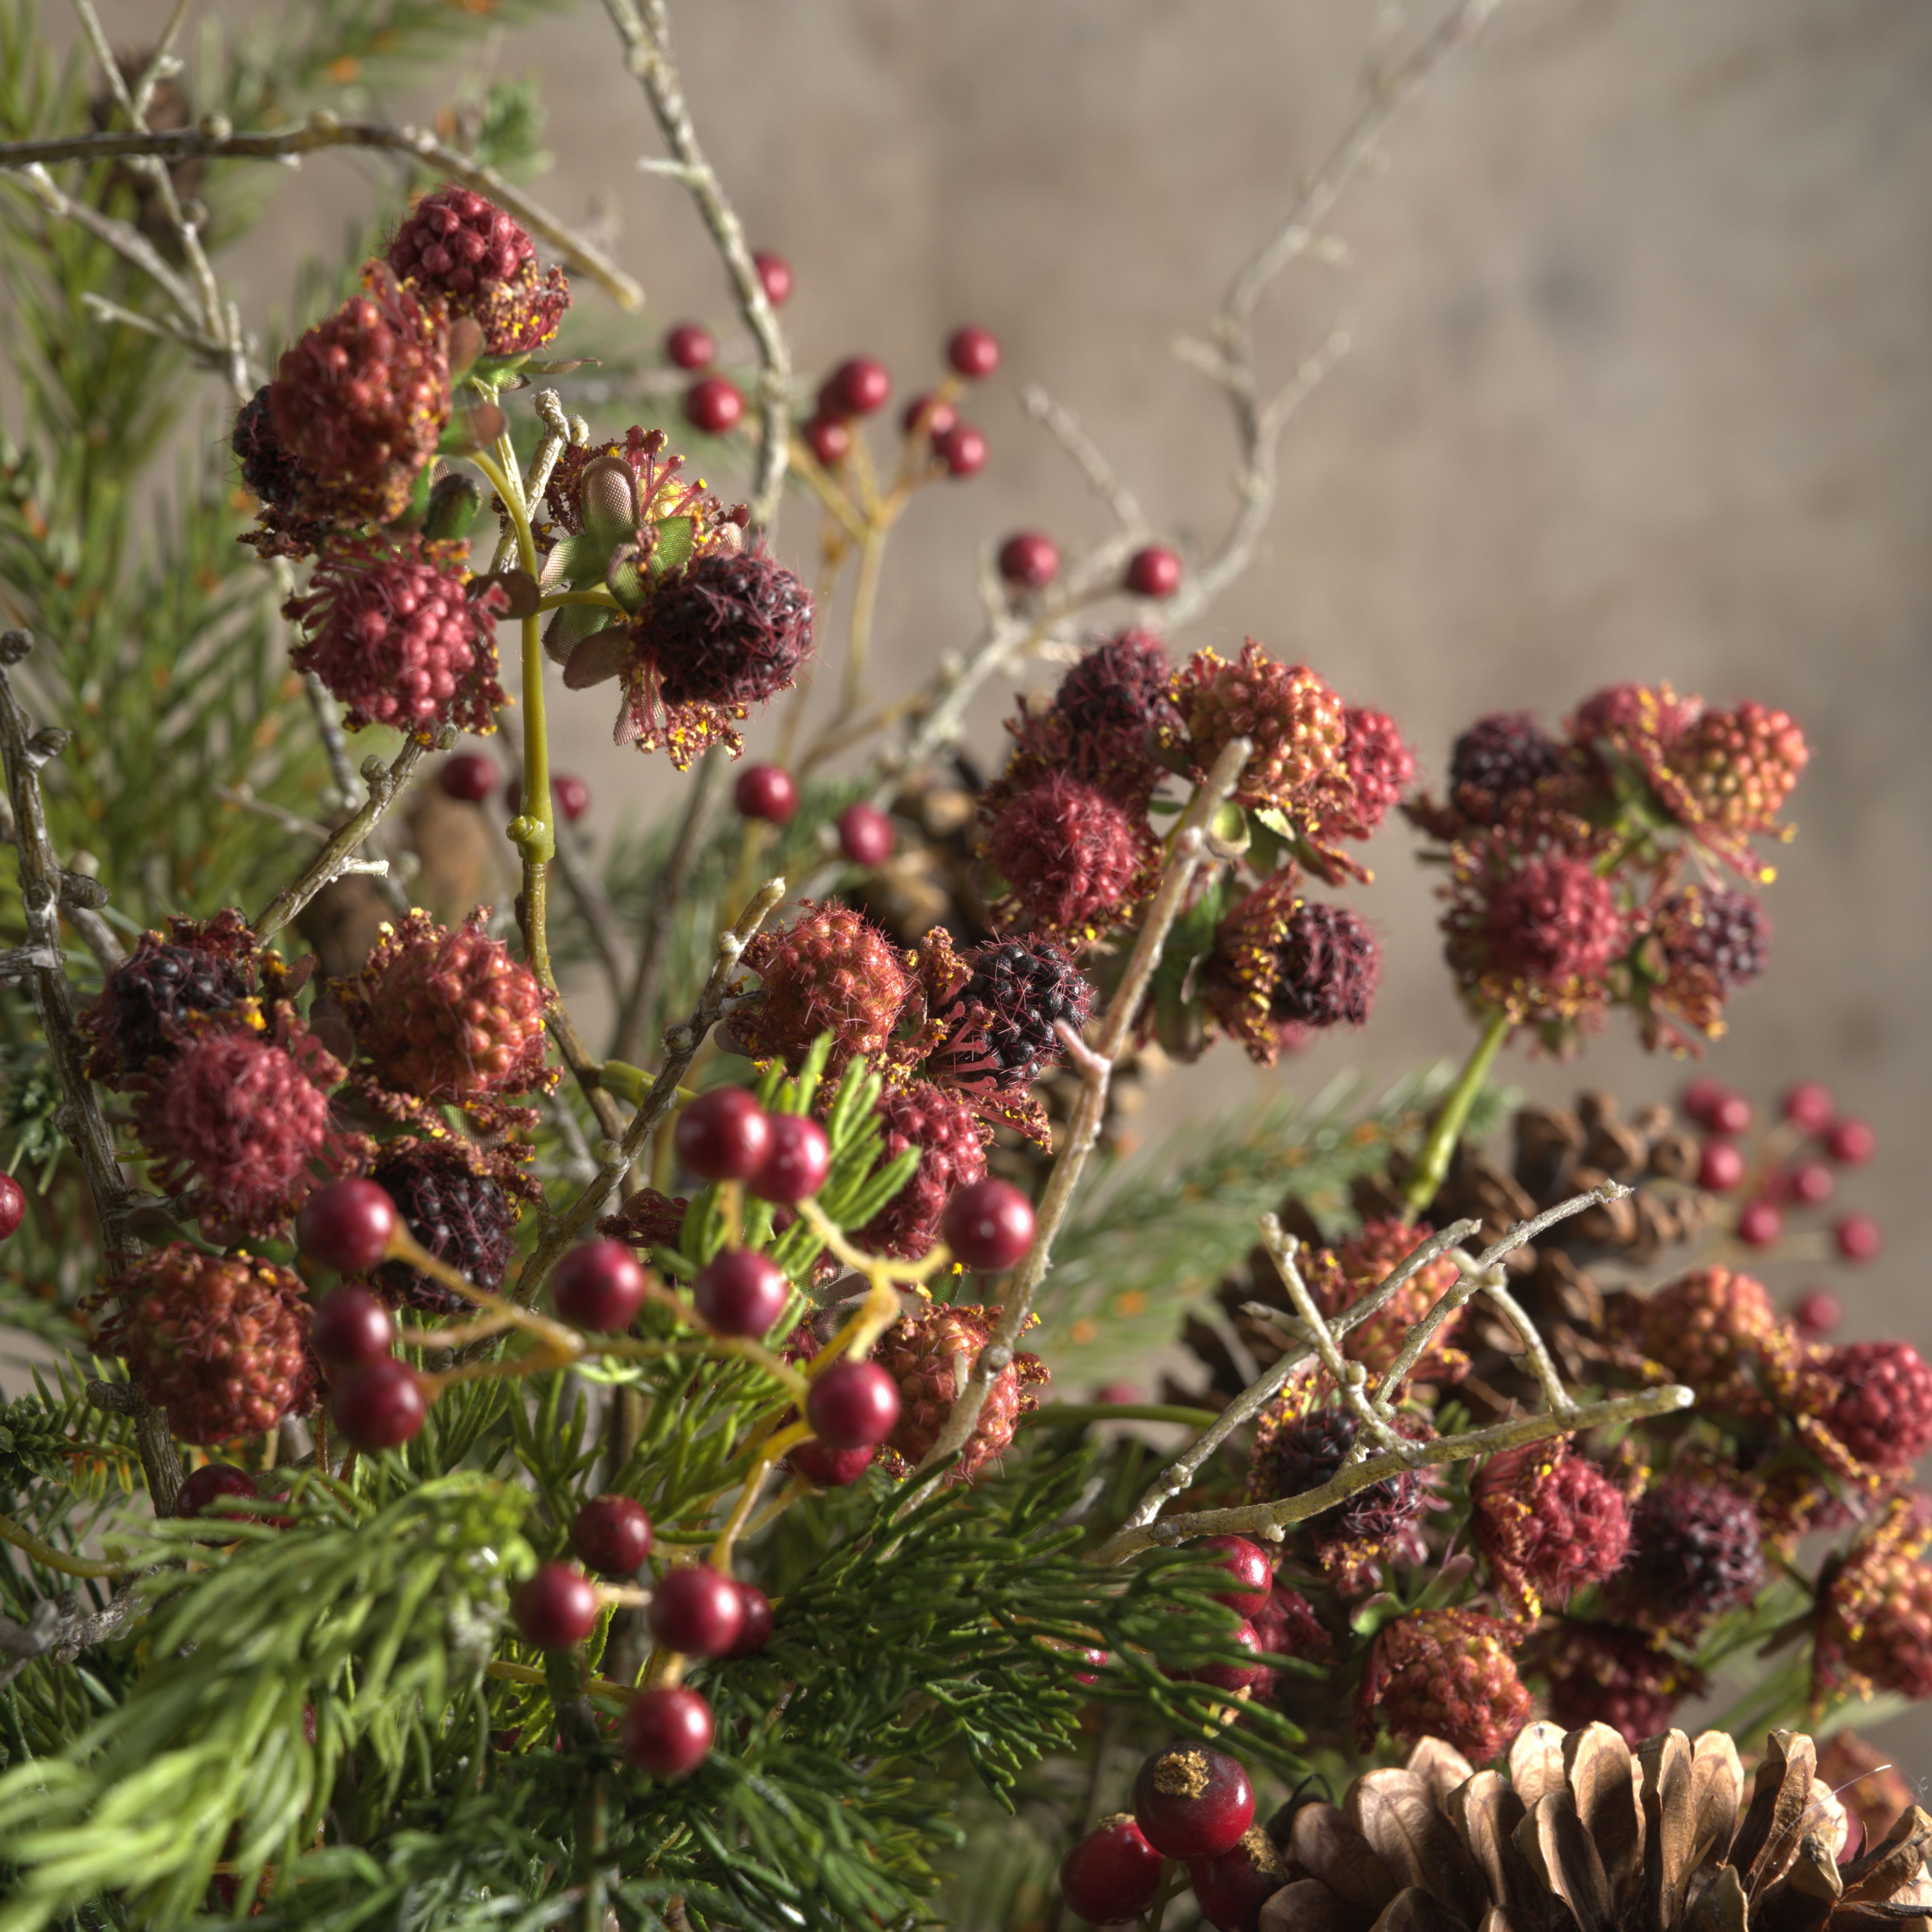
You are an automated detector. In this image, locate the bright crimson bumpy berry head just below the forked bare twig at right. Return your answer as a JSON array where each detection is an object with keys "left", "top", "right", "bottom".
[{"left": 1470, "top": 1439, "right": 1631, "bottom": 1619}]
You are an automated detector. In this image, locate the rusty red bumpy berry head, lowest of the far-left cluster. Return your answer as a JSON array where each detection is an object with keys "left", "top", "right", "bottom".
[{"left": 101, "top": 1240, "right": 315, "bottom": 1443}]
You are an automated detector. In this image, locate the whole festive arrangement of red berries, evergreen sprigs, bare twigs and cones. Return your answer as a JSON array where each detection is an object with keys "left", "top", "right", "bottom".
[{"left": 0, "top": 0, "right": 1932, "bottom": 1932}]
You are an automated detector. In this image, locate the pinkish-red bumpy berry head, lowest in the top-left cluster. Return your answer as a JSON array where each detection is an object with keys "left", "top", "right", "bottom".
[{"left": 282, "top": 537, "right": 508, "bottom": 738}]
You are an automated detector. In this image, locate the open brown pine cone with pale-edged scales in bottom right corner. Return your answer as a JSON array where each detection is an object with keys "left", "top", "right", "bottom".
[{"left": 1260, "top": 1723, "right": 1932, "bottom": 1932}]
